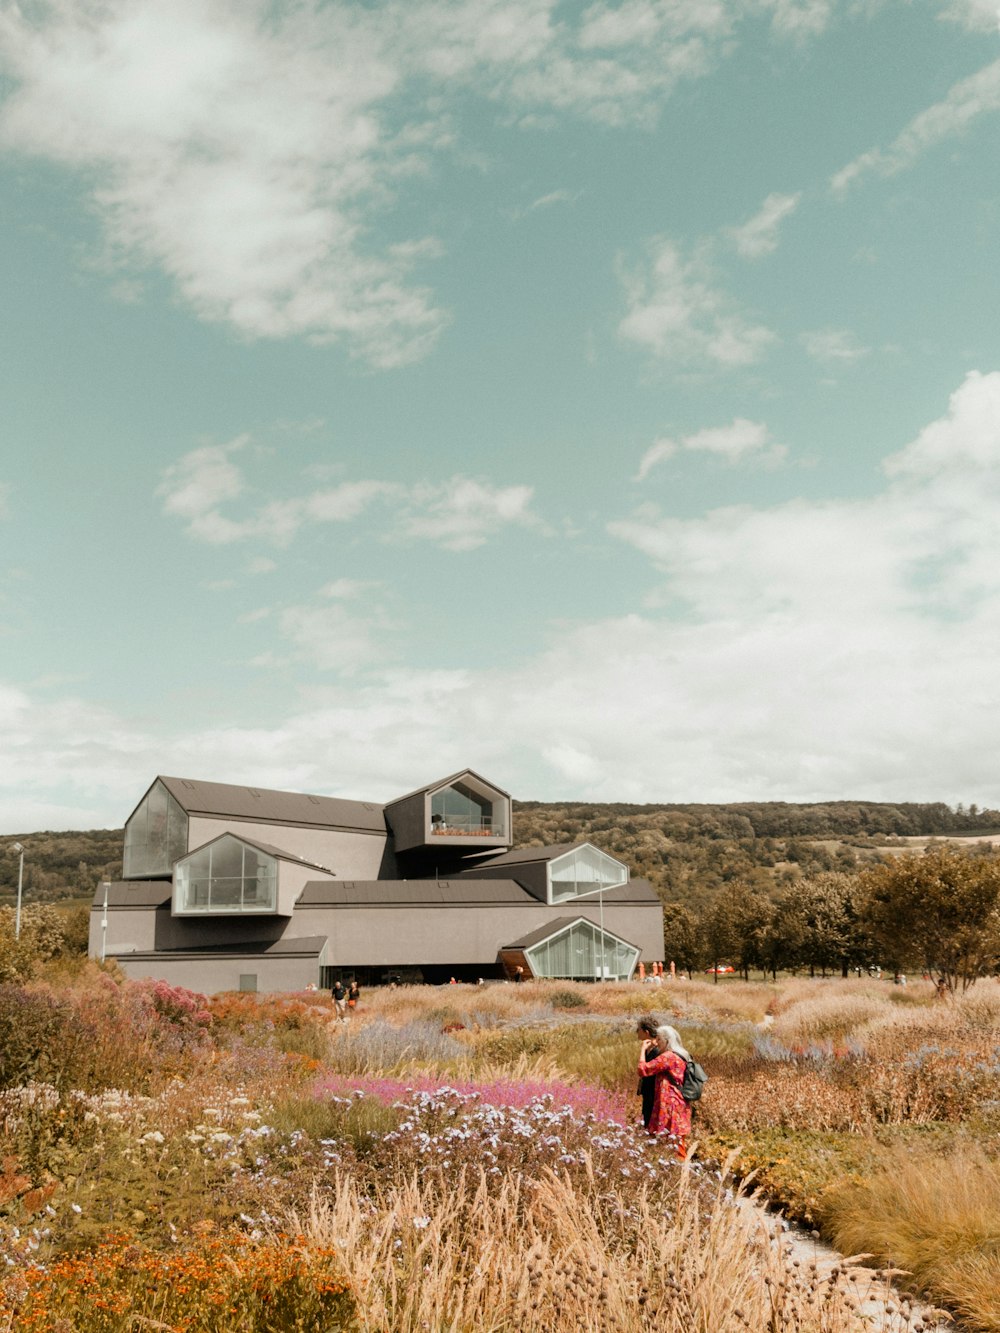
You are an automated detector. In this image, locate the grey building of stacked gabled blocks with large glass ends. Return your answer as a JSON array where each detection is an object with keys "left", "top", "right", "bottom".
[{"left": 91, "top": 769, "right": 663, "bottom": 993}]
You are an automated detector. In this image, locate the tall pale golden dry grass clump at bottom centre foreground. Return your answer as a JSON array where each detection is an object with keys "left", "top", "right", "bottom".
[{"left": 291, "top": 1170, "right": 912, "bottom": 1333}]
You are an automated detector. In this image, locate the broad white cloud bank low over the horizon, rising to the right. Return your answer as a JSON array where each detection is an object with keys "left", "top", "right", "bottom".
[{"left": 13, "top": 372, "right": 1000, "bottom": 832}]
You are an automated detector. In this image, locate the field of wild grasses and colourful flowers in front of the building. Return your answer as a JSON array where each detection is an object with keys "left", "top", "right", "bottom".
[{"left": 0, "top": 966, "right": 1000, "bottom": 1333}]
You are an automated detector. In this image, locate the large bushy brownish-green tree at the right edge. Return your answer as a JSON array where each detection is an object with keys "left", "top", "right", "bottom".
[{"left": 861, "top": 846, "right": 1000, "bottom": 990}]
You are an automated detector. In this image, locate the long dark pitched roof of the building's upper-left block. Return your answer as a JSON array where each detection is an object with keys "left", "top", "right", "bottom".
[{"left": 159, "top": 776, "right": 385, "bottom": 833}]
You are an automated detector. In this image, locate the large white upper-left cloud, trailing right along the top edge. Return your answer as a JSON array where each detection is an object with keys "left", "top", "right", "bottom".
[{"left": 0, "top": 0, "right": 828, "bottom": 367}]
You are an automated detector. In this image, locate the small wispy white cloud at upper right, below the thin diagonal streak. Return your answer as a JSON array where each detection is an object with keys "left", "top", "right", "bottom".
[{"left": 619, "top": 240, "right": 775, "bottom": 367}]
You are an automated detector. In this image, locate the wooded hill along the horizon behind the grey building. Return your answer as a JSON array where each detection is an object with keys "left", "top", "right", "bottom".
[{"left": 0, "top": 801, "right": 1000, "bottom": 909}]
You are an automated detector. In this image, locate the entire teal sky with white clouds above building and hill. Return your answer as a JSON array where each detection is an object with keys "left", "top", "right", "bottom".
[{"left": 0, "top": 0, "right": 1000, "bottom": 833}]
